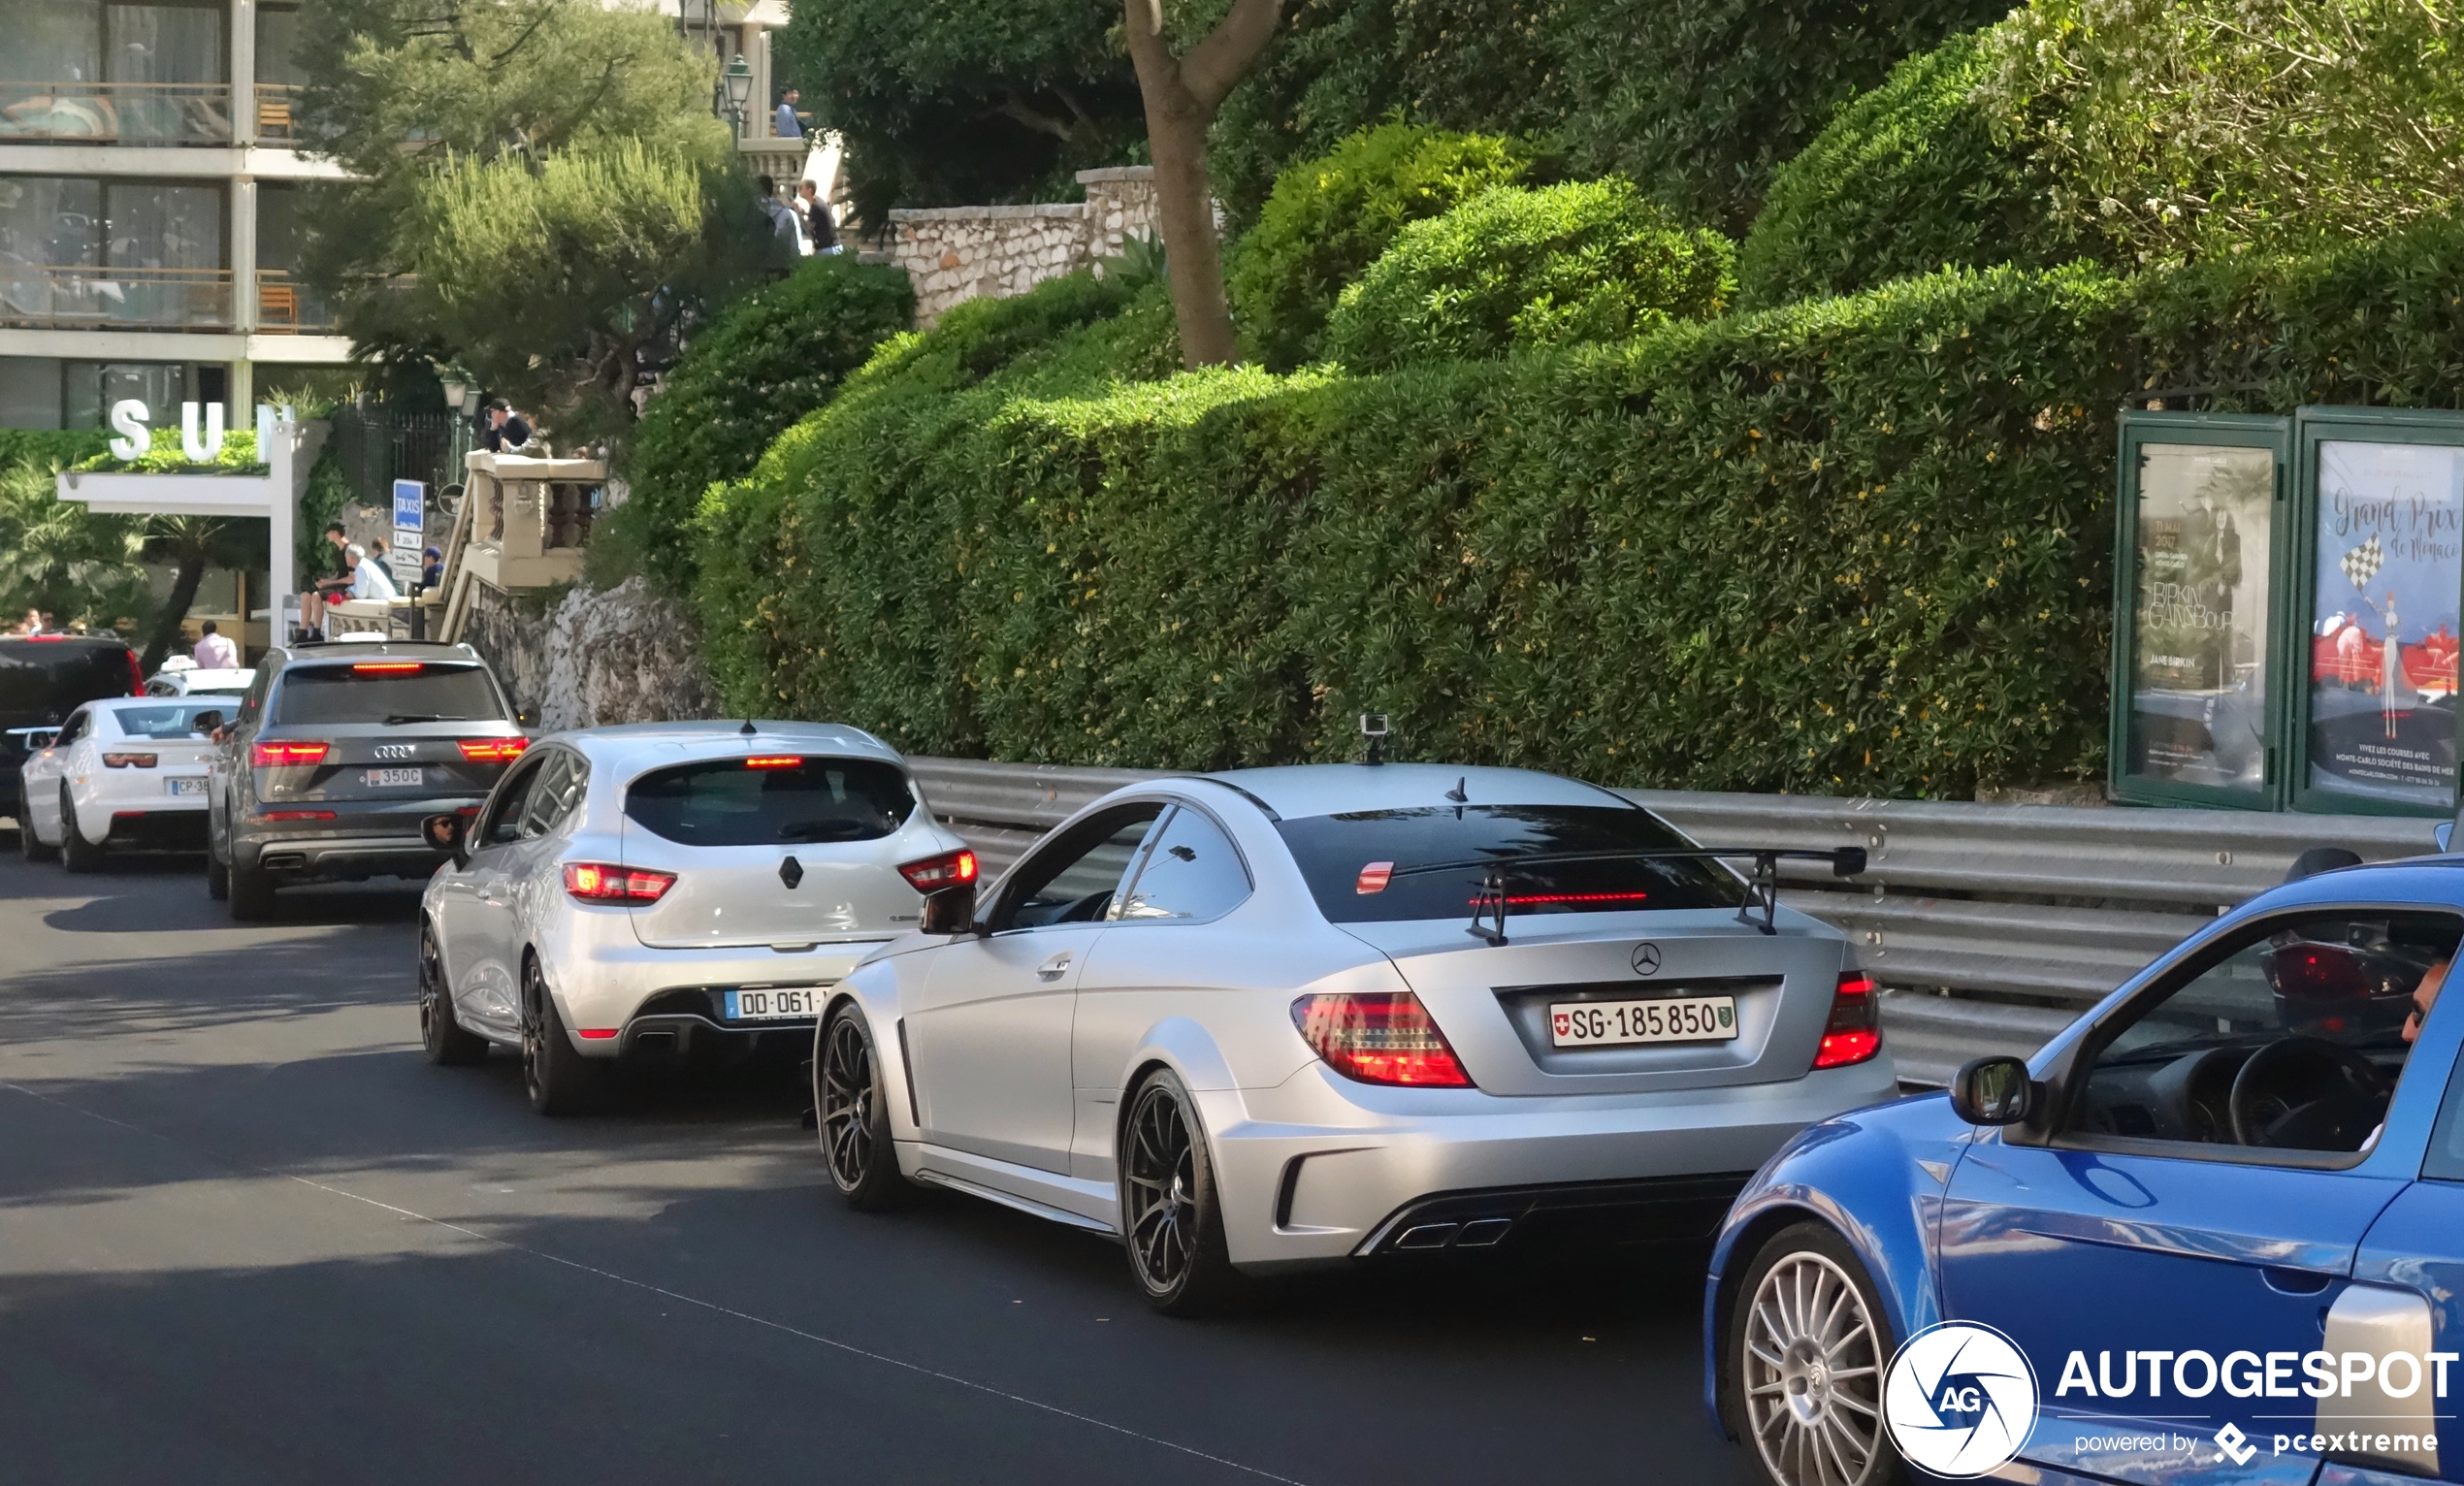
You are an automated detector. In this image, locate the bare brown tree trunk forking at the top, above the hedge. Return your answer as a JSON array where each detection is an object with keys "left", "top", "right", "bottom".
[{"left": 1123, "top": 0, "right": 1283, "bottom": 368}]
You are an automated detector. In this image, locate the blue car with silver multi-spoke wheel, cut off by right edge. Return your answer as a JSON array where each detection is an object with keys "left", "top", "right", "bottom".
[{"left": 1702, "top": 856, "right": 2464, "bottom": 1486}]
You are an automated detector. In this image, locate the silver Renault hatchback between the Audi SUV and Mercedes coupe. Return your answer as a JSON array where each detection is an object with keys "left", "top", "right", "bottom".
[{"left": 419, "top": 722, "right": 976, "bottom": 1114}]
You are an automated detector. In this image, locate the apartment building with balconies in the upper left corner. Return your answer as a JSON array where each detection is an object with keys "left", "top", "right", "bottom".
[{"left": 0, "top": 0, "right": 350, "bottom": 429}]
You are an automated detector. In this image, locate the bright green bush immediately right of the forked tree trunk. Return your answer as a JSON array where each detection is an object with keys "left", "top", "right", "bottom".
[{"left": 1224, "top": 123, "right": 1530, "bottom": 372}]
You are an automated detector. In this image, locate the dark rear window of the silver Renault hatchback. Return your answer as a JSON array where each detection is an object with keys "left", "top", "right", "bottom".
[{"left": 624, "top": 757, "right": 917, "bottom": 845}]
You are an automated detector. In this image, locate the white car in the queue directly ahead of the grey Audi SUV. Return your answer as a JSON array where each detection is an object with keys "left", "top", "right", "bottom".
[{"left": 17, "top": 695, "right": 237, "bottom": 872}]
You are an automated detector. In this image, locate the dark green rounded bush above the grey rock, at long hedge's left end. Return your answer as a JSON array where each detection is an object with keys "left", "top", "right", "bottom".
[{"left": 597, "top": 254, "right": 914, "bottom": 592}]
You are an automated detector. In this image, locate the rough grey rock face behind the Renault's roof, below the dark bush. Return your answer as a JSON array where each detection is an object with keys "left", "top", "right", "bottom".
[{"left": 464, "top": 579, "right": 720, "bottom": 732}]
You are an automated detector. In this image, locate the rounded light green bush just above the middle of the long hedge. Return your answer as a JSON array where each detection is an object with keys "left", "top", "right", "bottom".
[{"left": 1326, "top": 179, "right": 1737, "bottom": 372}]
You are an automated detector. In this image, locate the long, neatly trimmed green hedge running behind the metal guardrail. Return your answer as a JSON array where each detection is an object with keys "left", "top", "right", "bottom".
[{"left": 702, "top": 211, "right": 2464, "bottom": 796}]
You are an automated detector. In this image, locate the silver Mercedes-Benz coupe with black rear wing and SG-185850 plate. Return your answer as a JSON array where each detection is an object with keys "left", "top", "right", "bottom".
[{"left": 813, "top": 764, "right": 1895, "bottom": 1313}]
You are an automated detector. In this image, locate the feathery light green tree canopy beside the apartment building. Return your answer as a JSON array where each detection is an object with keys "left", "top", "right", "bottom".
[{"left": 301, "top": 0, "right": 766, "bottom": 432}]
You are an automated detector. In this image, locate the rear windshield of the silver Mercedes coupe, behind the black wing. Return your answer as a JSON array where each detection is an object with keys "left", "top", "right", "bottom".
[{"left": 1277, "top": 806, "right": 1744, "bottom": 924}]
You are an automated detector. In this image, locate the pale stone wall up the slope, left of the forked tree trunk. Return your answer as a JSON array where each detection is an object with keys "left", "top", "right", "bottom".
[{"left": 890, "top": 165, "right": 1160, "bottom": 325}]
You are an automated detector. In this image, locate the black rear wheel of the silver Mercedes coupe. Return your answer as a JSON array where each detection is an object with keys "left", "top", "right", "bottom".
[{"left": 1121, "top": 1072, "right": 1240, "bottom": 1316}]
